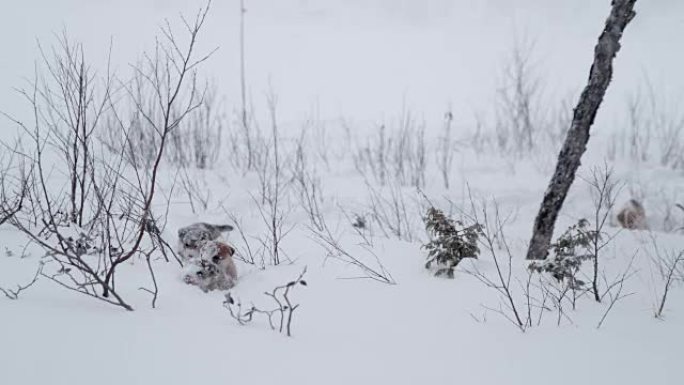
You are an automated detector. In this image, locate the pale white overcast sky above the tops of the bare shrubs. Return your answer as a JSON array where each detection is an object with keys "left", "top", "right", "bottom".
[{"left": 0, "top": 0, "right": 684, "bottom": 127}]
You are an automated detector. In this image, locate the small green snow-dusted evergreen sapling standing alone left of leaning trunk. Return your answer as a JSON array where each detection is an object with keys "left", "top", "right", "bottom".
[{"left": 423, "top": 207, "right": 480, "bottom": 278}]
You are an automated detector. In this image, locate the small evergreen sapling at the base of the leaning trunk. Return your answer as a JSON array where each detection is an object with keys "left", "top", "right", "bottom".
[{"left": 529, "top": 219, "right": 598, "bottom": 289}]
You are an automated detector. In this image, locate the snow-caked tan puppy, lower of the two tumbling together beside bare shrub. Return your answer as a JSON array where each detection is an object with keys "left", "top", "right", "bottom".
[{"left": 183, "top": 241, "right": 237, "bottom": 293}]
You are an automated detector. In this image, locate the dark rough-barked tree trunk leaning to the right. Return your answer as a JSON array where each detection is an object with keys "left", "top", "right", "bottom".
[{"left": 527, "top": 0, "right": 636, "bottom": 259}]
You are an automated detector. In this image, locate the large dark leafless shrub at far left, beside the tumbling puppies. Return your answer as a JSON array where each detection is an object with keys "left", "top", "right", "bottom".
[{"left": 0, "top": 6, "right": 214, "bottom": 310}]
